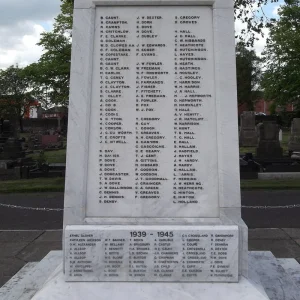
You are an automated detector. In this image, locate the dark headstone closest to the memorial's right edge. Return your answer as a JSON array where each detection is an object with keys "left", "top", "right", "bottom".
[{"left": 240, "top": 111, "right": 258, "bottom": 147}]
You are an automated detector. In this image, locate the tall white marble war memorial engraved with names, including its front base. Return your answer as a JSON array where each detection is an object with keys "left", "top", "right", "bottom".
[{"left": 28, "top": 0, "right": 266, "bottom": 300}]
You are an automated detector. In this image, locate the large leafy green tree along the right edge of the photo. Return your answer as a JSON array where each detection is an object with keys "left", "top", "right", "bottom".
[{"left": 262, "top": 0, "right": 300, "bottom": 110}]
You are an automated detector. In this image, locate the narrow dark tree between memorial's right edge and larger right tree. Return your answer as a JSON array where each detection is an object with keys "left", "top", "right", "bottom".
[{"left": 236, "top": 42, "right": 261, "bottom": 110}]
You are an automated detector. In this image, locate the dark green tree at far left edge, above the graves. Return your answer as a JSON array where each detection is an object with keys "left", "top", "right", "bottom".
[{"left": 0, "top": 66, "right": 33, "bottom": 131}]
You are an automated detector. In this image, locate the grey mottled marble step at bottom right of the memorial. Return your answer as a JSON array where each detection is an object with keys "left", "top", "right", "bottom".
[{"left": 249, "top": 251, "right": 300, "bottom": 300}]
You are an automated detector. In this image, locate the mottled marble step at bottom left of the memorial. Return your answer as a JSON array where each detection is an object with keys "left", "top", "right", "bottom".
[{"left": 0, "top": 251, "right": 62, "bottom": 300}]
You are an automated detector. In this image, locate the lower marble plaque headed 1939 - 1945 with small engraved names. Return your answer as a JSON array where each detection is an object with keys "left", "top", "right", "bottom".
[{"left": 65, "top": 225, "right": 239, "bottom": 282}]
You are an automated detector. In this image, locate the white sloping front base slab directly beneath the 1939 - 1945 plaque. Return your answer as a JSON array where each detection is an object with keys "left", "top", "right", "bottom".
[{"left": 32, "top": 267, "right": 269, "bottom": 300}]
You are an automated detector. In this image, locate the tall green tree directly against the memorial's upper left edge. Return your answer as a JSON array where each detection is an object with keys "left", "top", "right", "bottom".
[{"left": 24, "top": 0, "right": 73, "bottom": 105}]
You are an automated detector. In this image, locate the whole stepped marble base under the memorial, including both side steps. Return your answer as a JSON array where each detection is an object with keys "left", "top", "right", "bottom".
[{"left": 0, "top": 251, "right": 300, "bottom": 300}]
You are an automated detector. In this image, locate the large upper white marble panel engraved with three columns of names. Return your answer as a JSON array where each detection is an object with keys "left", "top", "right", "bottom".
[{"left": 87, "top": 6, "right": 219, "bottom": 217}]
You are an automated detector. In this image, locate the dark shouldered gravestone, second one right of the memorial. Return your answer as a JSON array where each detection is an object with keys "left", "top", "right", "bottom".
[{"left": 256, "top": 122, "right": 283, "bottom": 159}]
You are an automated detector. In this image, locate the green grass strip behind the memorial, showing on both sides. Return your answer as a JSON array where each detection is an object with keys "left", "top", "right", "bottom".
[{"left": 0, "top": 177, "right": 300, "bottom": 194}]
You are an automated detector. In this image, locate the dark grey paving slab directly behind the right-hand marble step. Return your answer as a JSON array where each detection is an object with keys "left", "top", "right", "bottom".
[{"left": 249, "top": 240, "right": 300, "bottom": 258}]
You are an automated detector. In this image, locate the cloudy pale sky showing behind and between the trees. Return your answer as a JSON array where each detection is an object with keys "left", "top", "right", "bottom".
[{"left": 0, "top": 0, "right": 284, "bottom": 69}]
